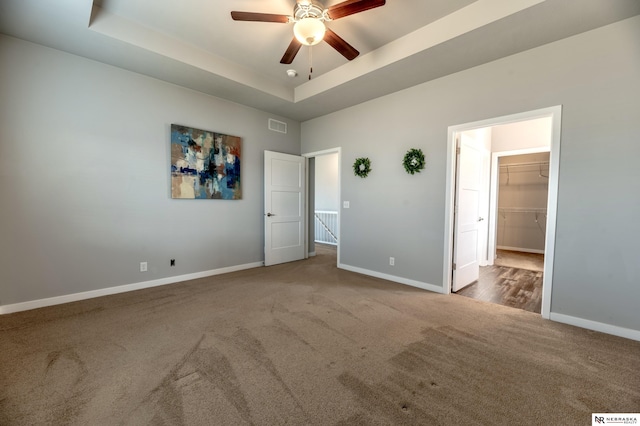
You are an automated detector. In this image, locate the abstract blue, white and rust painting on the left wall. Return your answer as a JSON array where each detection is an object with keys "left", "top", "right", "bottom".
[{"left": 171, "top": 124, "right": 242, "bottom": 200}]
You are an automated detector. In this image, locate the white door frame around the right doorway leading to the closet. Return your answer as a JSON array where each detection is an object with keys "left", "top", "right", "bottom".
[{"left": 443, "top": 105, "right": 562, "bottom": 319}]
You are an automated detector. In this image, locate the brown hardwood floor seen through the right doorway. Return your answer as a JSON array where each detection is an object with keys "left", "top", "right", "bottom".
[{"left": 456, "top": 265, "right": 542, "bottom": 313}]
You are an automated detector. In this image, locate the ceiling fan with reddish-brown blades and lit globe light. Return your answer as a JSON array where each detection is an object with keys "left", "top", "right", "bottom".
[{"left": 231, "top": 0, "right": 386, "bottom": 64}]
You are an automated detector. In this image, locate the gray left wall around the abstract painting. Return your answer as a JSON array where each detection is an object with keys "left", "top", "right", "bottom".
[{"left": 0, "top": 36, "right": 300, "bottom": 305}]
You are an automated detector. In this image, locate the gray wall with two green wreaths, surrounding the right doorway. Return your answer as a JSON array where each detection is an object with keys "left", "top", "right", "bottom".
[{"left": 302, "top": 17, "right": 640, "bottom": 330}]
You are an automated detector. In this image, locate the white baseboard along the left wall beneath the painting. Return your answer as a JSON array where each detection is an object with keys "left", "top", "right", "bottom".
[{"left": 0, "top": 262, "right": 264, "bottom": 315}]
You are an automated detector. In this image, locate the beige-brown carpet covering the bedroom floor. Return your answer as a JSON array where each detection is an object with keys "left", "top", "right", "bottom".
[{"left": 0, "top": 249, "right": 640, "bottom": 425}]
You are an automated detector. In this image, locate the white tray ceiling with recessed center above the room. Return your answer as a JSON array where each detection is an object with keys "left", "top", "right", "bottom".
[{"left": 0, "top": 0, "right": 640, "bottom": 121}]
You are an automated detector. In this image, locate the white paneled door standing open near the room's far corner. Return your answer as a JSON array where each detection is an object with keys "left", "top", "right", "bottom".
[{"left": 264, "top": 151, "right": 305, "bottom": 266}]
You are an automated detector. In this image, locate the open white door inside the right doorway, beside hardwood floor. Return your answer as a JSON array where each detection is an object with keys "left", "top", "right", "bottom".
[{"left": 451, "top": 134, "right": 484, "bottom": 291}]
